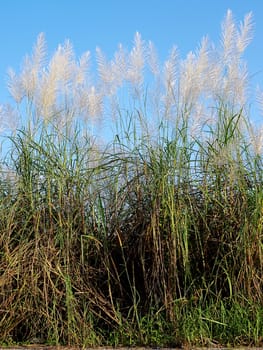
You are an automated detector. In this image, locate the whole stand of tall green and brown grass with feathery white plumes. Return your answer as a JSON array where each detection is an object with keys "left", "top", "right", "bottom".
[{"left": 0, "top": 11, "right": 263, "bottom": 346}]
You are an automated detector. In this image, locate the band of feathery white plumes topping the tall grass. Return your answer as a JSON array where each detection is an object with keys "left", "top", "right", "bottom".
[{"left": 2, "top": 10, "right": 253, "bottom": 145}]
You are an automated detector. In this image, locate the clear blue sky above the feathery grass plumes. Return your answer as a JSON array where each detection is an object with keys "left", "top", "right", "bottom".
[{"left": 0, "top": 0, "right": 263, "bottom": 103}]
